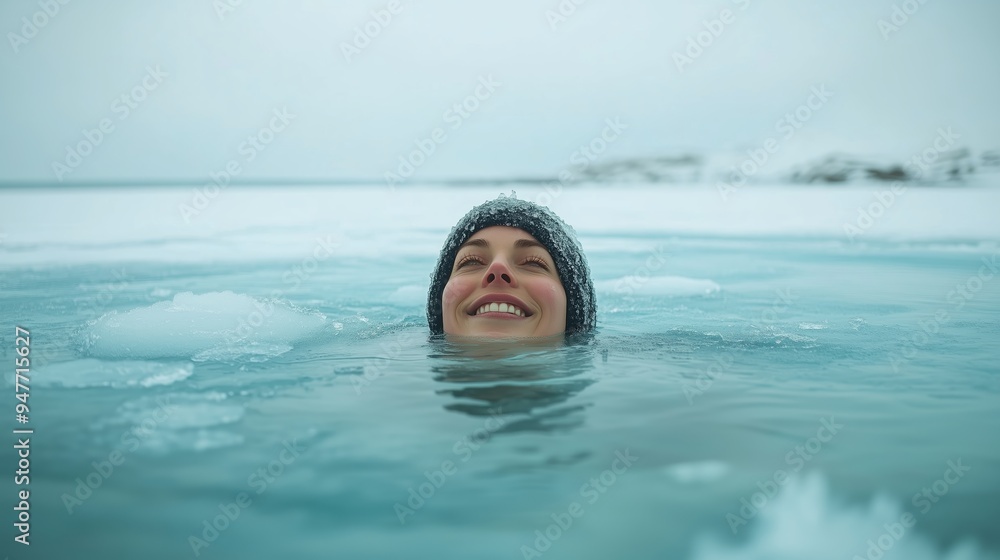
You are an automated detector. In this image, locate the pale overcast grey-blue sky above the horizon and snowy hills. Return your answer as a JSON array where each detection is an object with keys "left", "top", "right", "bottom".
[{"left": 0, "top": 0, "right": 1000, "bottom": 184}]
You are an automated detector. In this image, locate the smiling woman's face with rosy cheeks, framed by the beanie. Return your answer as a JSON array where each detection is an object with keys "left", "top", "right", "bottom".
[{"left": 441, "top": 226, "right": 566, "bottom": 338}]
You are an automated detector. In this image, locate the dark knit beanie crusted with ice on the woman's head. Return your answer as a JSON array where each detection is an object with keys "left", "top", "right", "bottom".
[{"left": 427, "top": 193, "right": 597, "bottom": 334}]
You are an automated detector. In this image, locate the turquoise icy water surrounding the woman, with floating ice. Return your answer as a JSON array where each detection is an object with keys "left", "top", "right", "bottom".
[{"left": 0, "top": 186, "right": 1000, "bottom": 560}]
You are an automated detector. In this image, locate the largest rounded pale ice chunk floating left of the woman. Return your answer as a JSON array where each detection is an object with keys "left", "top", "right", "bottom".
[{"left": 85, "top": 291, "right": 327, "bottom": 361}]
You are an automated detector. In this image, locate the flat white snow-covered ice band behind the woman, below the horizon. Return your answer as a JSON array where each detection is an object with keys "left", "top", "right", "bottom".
[{"left": 0, "top": 183, "right": 1000, "bottom": 268}]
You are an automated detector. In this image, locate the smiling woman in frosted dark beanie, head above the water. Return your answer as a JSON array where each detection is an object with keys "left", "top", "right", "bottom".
[{"left": 427, "top": 194, "right": 597, "bottom": 338}]
